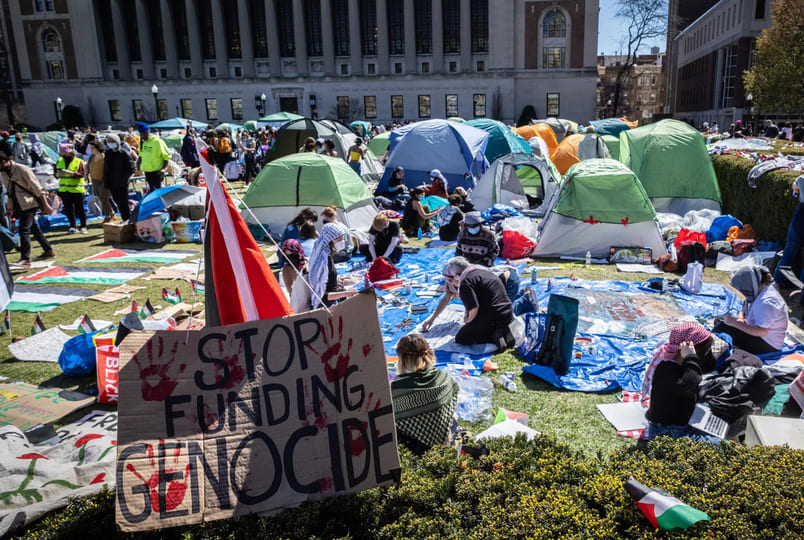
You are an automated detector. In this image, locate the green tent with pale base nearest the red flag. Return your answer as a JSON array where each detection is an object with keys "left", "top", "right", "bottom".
[{"left": 242, "top": 152, "right": 377, "bottom": 236}]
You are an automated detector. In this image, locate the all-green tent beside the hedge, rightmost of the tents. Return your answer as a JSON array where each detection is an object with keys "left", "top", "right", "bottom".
[{"left": 620, "top": 120, "right": 721, "bottom": 215}]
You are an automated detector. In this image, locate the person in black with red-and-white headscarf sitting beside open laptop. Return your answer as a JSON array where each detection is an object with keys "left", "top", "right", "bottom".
[{"left": 642, "top": 323, "right": 719, "bottom": 442}]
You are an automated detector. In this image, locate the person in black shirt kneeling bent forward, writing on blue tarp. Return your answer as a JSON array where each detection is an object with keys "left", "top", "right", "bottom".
[{"left": 422, "top": 257, "right": 516, "bottom": 351}]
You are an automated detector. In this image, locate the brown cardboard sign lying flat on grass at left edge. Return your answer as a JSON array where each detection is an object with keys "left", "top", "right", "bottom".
[{"left": 0, "top": 383, "right": 95, "bottom": 431}]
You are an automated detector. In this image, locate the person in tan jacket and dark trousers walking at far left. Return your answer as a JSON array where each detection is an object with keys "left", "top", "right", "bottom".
[{"left": 0, "top": 152, "right": 55, "bottom": 268}]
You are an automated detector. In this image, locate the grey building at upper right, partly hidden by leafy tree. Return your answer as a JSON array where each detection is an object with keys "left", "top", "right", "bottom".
[{"left": 665, "top": 0, "right": 773, "bottom": 128}]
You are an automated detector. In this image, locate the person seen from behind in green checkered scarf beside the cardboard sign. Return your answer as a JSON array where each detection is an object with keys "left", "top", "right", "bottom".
[{"left": 391, "top": 334, "right": 458, "bottom": 454}]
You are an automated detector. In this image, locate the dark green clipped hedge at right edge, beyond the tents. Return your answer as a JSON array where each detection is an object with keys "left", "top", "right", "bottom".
[{"left": 712, "top": 155, "right": 798, "bottom": 244}]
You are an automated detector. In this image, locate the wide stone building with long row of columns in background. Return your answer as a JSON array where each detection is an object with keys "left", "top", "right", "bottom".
[{"left": 0, "top": 0, "right": 599, "bottom": 127}]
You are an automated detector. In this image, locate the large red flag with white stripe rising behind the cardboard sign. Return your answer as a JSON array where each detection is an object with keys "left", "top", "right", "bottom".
[{"left": 201, "top": 150, "right": 293, "bottom": 325}]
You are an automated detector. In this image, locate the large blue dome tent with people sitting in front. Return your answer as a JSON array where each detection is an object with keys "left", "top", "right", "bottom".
[{"left": 377, "top": 120, "right": 489, "bottom": 193}]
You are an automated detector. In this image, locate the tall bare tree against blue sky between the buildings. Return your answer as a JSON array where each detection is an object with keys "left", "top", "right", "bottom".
[{"left": 607, "top": 0, "right": 667, "bottom": 117}]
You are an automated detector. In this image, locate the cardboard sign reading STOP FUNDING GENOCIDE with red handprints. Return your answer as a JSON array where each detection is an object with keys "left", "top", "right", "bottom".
[{"left": 116, "top": 293, "right": 400, "bottom": 531}]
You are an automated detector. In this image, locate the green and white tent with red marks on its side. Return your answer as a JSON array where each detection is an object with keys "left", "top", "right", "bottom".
[{"left": 533, "top": 159, "right": 666, "bottom": 258}]
